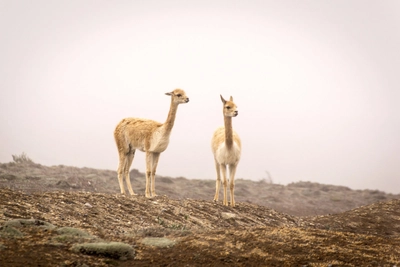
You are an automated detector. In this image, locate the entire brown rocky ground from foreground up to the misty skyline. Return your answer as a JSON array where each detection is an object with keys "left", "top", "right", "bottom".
[{"left": 0, "top": 159, "right": 400, "bottom": 267}]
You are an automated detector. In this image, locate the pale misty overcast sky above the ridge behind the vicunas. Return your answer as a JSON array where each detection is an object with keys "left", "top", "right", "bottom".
[{"left": 0, "top": 0, "right": 400, "bottom": 193}]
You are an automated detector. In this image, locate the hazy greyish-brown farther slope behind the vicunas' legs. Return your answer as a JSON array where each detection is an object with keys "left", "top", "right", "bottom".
[{"left": 0, "top": 161, "right": 400, "bottom": 216}]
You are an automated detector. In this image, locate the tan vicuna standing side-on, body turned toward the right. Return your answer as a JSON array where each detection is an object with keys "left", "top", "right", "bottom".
[{"left": 114, "top": 89, "right": 189, "bottom": 197}]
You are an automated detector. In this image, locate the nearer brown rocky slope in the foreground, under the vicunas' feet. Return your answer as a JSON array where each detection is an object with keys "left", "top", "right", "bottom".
[{"left": 0, "top": 189, "right": 400, "bottom": 267}]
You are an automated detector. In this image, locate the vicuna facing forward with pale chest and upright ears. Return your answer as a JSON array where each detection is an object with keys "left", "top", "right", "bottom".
[{"left": 211, "top": 96, "right": 242, "bottom": 207}]
